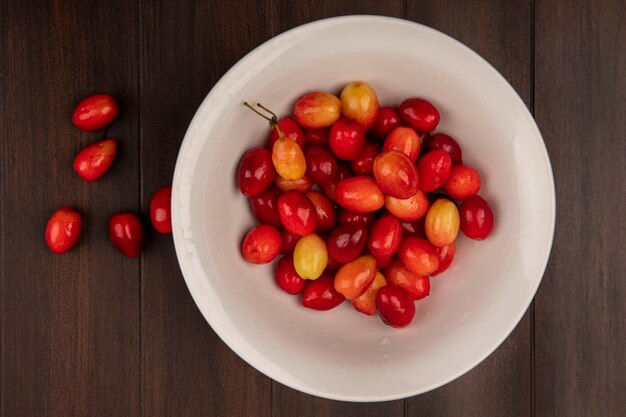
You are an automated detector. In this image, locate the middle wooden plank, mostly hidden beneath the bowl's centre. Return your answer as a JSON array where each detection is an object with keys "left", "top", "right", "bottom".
[{"left": 272, "top": 0, "right": 404, "bottom": 417}]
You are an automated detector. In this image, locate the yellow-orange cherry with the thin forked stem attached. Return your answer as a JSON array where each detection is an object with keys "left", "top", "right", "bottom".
[{"left": 243, "top": 102, "right": 306, "bottom": 181}]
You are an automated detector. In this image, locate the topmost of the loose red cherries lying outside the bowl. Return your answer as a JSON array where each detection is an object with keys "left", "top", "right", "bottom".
[{"left": 72, "top": 94, "right": 118, "bottom": 132}]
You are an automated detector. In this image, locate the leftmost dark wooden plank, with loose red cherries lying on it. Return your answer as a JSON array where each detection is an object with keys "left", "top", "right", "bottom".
[{"left": 0, "top": 0, "right": 140, "bottom": 417}]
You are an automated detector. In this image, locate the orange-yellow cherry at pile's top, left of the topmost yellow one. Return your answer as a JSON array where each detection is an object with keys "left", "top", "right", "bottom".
[{"left": 293, "top": 91, "right": 341, "bottom": 129}]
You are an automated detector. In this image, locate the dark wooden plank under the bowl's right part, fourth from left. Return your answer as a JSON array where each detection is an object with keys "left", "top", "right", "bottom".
[{"left": 407, "top": 0, "right": 532, "bottom": 417}]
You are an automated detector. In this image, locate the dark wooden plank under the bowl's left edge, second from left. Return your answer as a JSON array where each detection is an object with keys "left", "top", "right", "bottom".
[{"left": 141, "top": 0, "right": 271, "bottom": 417}]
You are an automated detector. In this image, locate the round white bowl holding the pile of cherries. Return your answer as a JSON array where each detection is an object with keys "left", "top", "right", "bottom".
[{"left": 172, "top": 16, "right": 555, "bottom": 401}]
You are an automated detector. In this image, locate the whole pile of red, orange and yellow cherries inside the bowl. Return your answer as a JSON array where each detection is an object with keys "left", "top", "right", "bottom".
[{"left": 237, "top": 82, "right": 494, "bottom": 327}]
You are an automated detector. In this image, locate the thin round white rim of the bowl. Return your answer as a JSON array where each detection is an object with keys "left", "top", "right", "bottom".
[{"left": 171, "top": 14, "right": 556, "bottom": 402}]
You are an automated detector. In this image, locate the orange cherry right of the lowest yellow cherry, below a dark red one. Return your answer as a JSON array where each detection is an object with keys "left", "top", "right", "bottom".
[{"left": 335, "top": 255, "right": 376, "bottom": 300}]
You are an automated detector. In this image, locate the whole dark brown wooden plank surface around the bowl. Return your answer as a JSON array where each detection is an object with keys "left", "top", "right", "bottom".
[{"left": 0, "top": 0, "right": 626, "bottom": 417}]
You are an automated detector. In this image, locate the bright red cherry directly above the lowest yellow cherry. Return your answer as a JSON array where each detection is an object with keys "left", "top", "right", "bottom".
[{"left": 278, "top": 191, "right": 317, "bottom": 236}]
